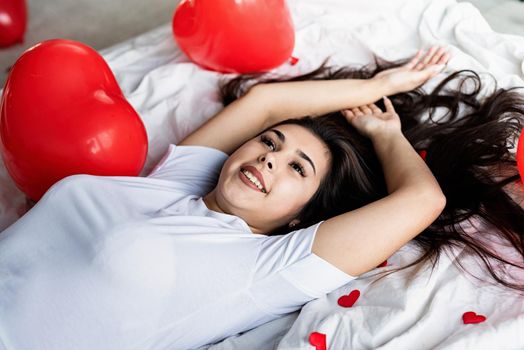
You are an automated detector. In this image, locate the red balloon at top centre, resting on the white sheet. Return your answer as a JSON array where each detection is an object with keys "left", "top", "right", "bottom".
[{"left": 173, "top": 0, "right": 295, "bottom": 73}]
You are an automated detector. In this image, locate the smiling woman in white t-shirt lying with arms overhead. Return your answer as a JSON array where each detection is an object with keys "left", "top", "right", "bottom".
[{"left": 0, "top": 48, "right": 522, "bottom": 349}]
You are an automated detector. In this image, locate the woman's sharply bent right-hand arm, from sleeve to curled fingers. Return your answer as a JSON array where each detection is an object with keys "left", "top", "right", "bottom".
[{"left": 312, "top": 99, "right": 446, "bottom": 276}]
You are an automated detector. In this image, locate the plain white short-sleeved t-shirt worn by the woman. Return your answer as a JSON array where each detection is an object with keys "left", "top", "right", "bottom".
[{"left": 0, "top": 145, "right": 355, "bottom": 350}]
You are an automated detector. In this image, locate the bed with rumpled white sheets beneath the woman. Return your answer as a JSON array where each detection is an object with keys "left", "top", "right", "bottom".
[{"left": 0, "top": 0, "right": 524, "bottom": 350}]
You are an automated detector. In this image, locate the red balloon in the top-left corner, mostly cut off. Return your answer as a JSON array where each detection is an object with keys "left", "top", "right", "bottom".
[{"left": 0, "top": 0, "right": 27, "bottom": 47}]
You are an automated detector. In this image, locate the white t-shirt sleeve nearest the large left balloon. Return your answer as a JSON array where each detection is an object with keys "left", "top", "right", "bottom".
[{"left": 147, "top": 144, "right": 228, "bottom": 196}]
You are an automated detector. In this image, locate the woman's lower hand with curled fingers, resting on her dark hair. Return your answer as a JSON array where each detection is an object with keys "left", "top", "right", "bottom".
[{"left": 341, "top": 96, "right": 402, "bottom": 139}]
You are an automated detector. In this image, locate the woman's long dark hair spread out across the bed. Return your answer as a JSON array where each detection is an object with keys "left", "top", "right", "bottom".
[{"left": 220, "top": 58, "right": 524, "bottom": 294}]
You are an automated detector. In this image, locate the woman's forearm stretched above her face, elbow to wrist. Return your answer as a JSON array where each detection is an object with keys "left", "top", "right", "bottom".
[{"left": 256, "top": 79, "right": 390, "bottom": 123}]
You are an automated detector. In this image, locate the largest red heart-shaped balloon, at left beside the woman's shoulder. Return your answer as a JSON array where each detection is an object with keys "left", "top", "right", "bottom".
[{"left": 0, "top": 39, "right": 147, "bottom": 200}]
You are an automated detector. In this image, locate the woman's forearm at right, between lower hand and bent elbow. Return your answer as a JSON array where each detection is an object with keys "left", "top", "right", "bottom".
[{"left": 371, "top": 131, "right": 444, "bottom": 197}]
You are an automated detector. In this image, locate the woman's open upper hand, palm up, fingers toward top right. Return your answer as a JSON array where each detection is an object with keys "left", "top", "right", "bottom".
[{"left": 373, "top": 46, "right": 450, "bottom": 95}]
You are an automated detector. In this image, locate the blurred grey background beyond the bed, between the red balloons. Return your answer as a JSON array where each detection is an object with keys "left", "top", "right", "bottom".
[{"left": 0, "top": 0, "right": 180, "bottom": 88}]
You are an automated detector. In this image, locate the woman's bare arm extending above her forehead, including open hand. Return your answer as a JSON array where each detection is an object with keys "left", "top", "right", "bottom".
[{"left": 179, "top": 47, "right": 445, "bottom": 154}]
